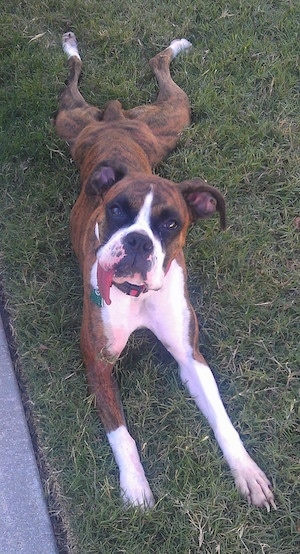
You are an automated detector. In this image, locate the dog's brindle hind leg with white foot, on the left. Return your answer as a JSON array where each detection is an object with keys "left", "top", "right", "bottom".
[{"left": 55, "top": 32, "right": 103, "bottom": 146}]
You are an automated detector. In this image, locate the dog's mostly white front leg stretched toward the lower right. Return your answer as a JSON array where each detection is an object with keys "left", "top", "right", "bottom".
[{"left": 149, "top": 259, "right": 276, "bottom": 510}]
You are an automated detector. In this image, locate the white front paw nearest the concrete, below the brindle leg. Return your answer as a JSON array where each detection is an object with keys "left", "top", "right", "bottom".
[{"left": 120, "top": 472, "right": 155, "bottom": 510}]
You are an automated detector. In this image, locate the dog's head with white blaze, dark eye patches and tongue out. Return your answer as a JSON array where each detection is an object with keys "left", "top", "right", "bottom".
[{"left": 92, "top": 174, "right": 225, "bottom": 304}]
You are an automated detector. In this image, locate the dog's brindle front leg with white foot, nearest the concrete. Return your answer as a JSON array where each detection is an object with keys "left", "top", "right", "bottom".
[{"left": 81, "top": 300, "right": 154, "bottom": 508}]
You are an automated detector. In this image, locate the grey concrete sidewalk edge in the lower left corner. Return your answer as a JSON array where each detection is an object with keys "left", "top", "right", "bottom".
[{"left": 0, "top": 317, "right": 58, "bottom": 554}]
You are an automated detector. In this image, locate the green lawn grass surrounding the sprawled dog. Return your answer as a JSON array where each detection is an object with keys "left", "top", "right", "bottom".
[{"left": 0, "top": 0, "right": 300, "bottom": 554}]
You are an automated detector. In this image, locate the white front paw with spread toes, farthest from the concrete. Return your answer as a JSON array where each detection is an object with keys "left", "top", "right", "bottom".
[{"left": 232, "top": 457, "right": 277, "bottom": 512}]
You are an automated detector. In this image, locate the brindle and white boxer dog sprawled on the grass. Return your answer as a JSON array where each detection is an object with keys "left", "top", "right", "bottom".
[{"left": 55, "top": 32, "right": 276, "bottom": 511}]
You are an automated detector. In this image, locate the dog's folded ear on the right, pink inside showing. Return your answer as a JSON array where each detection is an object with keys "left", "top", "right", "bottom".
[{"left": 178, "top": 178, "right": 226, "bottom": 230}]
